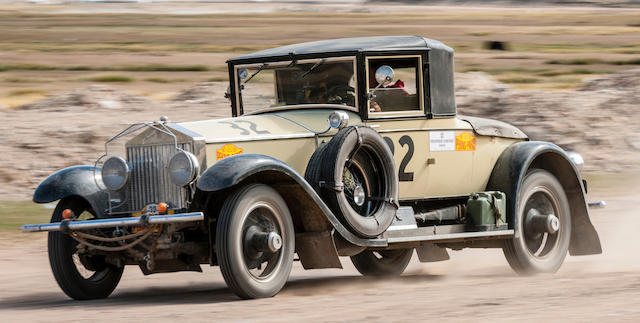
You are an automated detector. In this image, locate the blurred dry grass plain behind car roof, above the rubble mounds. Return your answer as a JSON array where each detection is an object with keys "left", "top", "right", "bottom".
[{"left": 0, "top": 7, "right": 640, "bottom": 93}]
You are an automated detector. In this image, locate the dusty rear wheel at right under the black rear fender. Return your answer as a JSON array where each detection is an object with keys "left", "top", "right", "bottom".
[{"left": 503, "top": 169, "right": 571, "bottom": 275}]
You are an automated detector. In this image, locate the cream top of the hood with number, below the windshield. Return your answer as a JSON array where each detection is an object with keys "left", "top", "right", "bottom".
[{"left": 178, "top": 109, "right": 362, "bottom": 143}]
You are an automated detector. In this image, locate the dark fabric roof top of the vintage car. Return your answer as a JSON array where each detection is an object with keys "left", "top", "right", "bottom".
[{"left": 229, "top": 36, "right": 453, "bottom": 63}]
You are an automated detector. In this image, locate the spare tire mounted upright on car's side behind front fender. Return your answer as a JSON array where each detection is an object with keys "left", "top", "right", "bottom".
[{"left": 305, "top": 127, "right": 398, "bottom": 238}]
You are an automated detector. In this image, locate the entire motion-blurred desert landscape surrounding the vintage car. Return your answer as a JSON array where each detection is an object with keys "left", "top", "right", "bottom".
[{"left": 0, "top": 0, "right": 640, "bottom": 322}]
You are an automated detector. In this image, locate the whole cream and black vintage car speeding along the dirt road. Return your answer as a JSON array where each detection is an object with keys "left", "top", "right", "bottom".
[{"left": 22, "top": 36, "right": 601, "bottom": 299}]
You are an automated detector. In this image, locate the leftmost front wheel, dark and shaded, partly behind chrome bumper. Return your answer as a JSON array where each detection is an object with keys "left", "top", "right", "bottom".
[{"left": 48, "top": 199, "right": 124, "bottom": 300}]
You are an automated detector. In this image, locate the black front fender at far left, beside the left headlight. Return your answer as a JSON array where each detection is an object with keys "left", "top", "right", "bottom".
[{"left": 33, "top": 165, "right": 109, "bottom": 217}]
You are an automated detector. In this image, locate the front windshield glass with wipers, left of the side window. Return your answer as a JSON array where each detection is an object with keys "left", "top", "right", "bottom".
[{"left": 236, "top": 59, "right": 356, "bottom": 114}]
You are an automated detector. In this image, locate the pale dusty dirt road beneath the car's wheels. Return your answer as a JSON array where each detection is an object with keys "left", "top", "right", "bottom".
[{"left": 0, "top": 175, "right": 640, "bottom": 322}]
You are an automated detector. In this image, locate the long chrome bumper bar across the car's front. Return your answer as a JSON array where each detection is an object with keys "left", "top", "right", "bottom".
[{"left": 21, "top": 212, "right": 204, "bottom": 232}]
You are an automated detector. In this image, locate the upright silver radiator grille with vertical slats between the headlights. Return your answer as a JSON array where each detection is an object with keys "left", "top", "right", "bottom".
[{"left": 127, "top": 143, "right": 193, "bottom": 210}]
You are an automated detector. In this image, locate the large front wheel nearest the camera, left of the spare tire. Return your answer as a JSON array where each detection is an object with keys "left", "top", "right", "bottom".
[{"left": 216, "top": 184, "right": 295, "bottom": 299}]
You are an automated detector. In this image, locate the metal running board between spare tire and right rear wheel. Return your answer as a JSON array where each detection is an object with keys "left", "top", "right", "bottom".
[{"left": 383, "top": 224, "right": 514, "bottom": 244}]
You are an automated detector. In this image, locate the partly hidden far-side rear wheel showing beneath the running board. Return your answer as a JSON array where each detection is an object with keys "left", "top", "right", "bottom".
[{"left": 351, "top": 249, "right": 413, "bottom": 276}]
